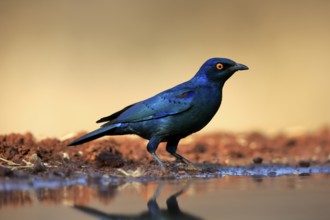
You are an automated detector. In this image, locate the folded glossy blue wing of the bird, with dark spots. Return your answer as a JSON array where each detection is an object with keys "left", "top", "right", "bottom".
[{"left": 97, "top": 89, "right": 195, "bottom": 126}]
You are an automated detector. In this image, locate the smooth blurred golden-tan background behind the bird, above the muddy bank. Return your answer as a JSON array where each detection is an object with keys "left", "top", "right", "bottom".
[{"left": 0, "top": 0, "right": 330, "bottom": 137}]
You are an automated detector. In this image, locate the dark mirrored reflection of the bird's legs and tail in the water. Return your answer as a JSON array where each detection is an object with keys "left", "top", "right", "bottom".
[{"left": 73, "top": 182, "right": 201, "bottom": 219}]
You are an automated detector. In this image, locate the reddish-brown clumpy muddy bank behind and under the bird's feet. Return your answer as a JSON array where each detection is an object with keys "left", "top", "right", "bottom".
[{"left": 0, "top": 127, "right": 330, "bottom": 178}]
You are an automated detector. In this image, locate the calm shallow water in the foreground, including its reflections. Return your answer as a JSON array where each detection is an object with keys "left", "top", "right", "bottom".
[{"left": 0, "top": 174, "right": 330, "bottom": 220}]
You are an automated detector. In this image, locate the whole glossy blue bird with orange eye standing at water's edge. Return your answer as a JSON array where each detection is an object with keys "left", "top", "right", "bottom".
[{"left": 68, "top": 58, "right": 248, "bottom": 170}]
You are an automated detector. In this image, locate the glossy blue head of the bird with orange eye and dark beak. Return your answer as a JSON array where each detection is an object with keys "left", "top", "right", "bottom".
[{"left": 194, "top": 58, "right": 249, "bottom": 83}]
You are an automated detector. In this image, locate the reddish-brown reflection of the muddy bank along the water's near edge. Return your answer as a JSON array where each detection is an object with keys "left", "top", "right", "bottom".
[{"left": 0, "top": 175, "right": 329, "bottom": 207}]
